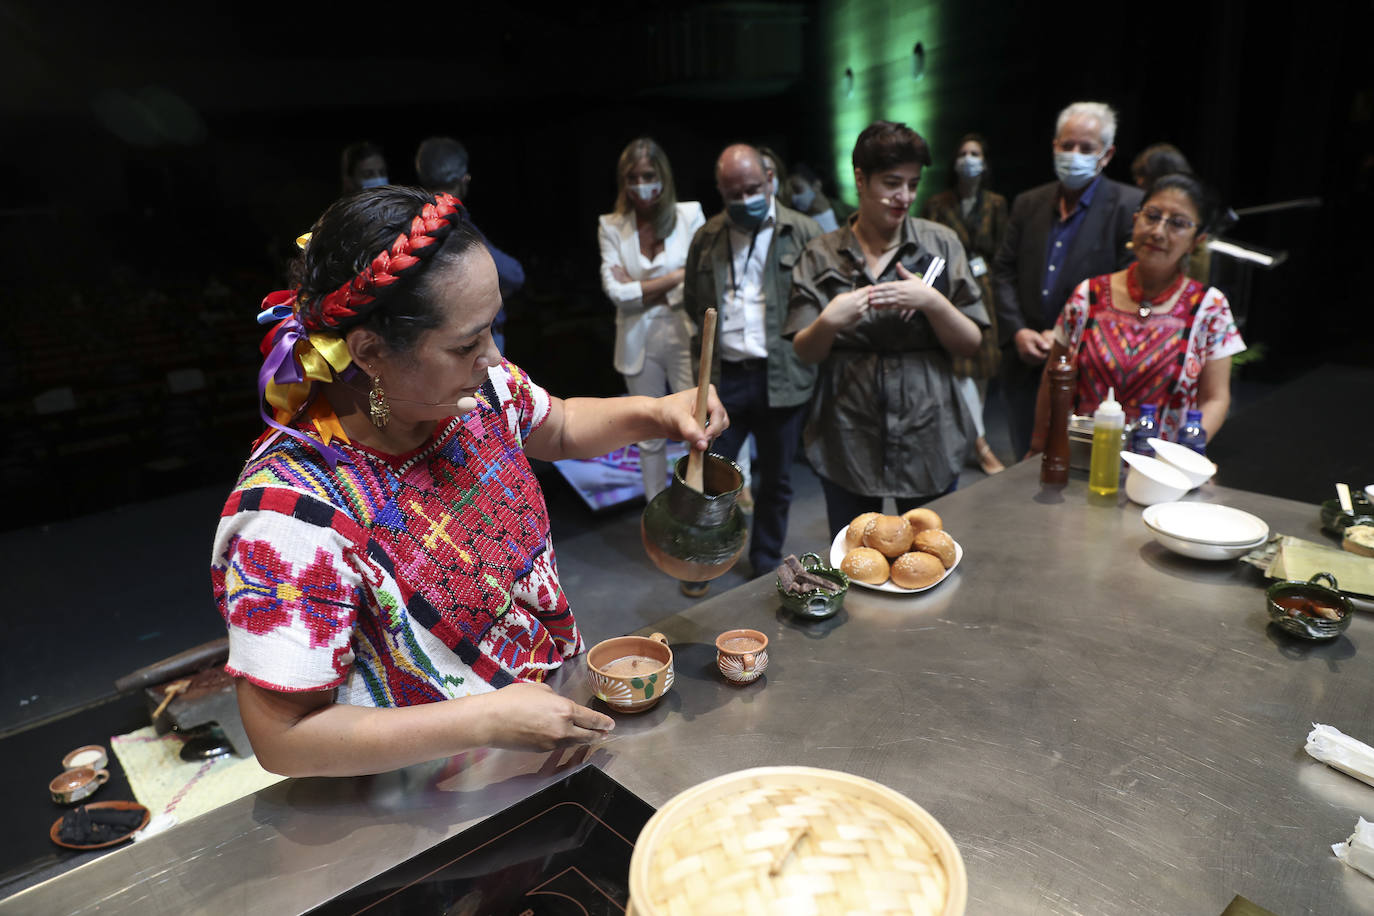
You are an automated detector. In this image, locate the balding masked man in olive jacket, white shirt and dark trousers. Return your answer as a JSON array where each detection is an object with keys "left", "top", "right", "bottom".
[{"left": 683, "top": 144, "right": 820, "bottom": 579}]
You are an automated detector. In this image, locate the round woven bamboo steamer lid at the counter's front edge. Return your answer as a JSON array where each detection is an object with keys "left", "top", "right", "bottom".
[{"left": 629, "top": 766, "right": 967, "bottom": 916}]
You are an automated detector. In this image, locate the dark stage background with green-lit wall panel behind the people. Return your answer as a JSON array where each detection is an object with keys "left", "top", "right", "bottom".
[{"left": 0, "top": 0, "right": 1374, "bottom": 530}]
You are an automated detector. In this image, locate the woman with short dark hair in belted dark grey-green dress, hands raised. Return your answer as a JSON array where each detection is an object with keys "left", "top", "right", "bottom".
[{"left": 783, "top": 121, "right": 988, "bottom": 530}]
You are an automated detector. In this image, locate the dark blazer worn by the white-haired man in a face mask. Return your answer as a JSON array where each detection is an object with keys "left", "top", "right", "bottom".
[{"left": 992, "top": 177, "right": 1143, "bottom": 346}]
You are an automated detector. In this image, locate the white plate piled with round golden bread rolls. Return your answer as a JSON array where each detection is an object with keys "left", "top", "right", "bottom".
[{"left": 830, "top": 507, "right": 963, "bottom": 595}]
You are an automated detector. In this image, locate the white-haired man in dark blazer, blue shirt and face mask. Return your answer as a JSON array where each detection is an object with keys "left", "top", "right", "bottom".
[{"left": 992, "top": 102, "right": 1142, "bottom": 456}]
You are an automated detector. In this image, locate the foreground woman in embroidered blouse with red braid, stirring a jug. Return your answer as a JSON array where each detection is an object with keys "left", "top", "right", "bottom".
[{"left": 212, "top": 187, "right": 727, "bottom": 776}]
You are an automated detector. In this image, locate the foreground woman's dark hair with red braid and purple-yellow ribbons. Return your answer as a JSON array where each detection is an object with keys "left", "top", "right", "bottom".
[{"left": 250, "top": 187, "right": 481, "bottom": 467}]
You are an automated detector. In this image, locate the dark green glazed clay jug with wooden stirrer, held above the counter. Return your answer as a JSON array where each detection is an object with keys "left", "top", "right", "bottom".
[{"left": 639, "top": 453, "right": 747, "bottom": 582}]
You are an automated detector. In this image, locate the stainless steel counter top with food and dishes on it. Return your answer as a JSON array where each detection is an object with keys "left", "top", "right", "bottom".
[{"left": 10, "top": 464, "right": 1374, "bottom": 915}]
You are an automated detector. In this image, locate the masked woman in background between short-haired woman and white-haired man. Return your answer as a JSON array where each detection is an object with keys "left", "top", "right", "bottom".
[{"left": 921, "top": 133, "right": 1007, "bottom": 474}]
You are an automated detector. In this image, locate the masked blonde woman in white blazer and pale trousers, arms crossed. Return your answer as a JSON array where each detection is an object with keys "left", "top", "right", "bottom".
[{"left": 599, "top": 137, "right": 706, "bottom": 500}]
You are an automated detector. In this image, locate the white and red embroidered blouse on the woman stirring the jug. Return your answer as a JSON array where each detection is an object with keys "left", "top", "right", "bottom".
[{"left": 212, "top": 363, "right": 583, "bottom": 706}]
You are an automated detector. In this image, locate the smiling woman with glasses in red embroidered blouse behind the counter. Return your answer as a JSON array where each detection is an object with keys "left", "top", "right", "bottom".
[{"left": 1031, "top": 174, "right": 1245, "bottom": 455}]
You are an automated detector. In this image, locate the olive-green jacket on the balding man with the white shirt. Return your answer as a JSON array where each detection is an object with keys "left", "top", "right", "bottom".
[{"left": 683, "top": 207, "right": 820, "bottom": 407}]
